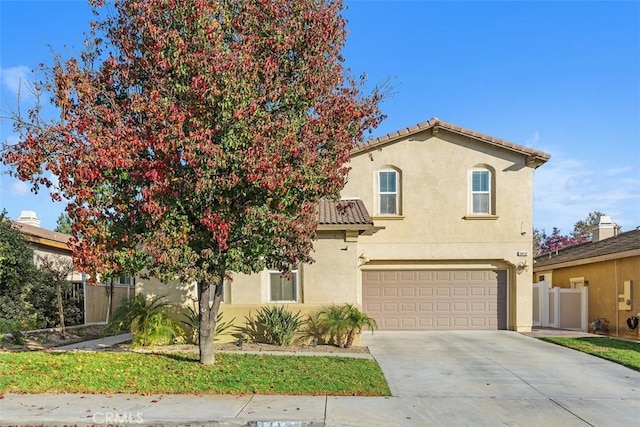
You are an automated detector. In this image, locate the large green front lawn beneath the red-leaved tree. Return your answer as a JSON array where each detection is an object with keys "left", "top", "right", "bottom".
[{"left": 0, "top": 352, "right": 390, "bottom": 396}]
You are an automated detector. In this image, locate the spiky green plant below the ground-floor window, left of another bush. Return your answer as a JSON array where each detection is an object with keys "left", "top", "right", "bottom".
[{"left": 255, "top": 306, "right": 305, "bottom": 345}]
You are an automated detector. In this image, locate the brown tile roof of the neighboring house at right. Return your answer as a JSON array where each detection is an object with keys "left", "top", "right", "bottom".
[{"left": 534, "top": 227, "right": 640, "bottom": 268}]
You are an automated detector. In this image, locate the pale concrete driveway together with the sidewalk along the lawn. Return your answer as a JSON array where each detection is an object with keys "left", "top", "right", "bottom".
[{"left": 0, "top": 331, "right": 640, "bottom": 427}]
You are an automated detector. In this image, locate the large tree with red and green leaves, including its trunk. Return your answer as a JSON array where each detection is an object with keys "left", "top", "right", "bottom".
[{"left": 3, "top": 0, "right": 382, "bottom": 364}]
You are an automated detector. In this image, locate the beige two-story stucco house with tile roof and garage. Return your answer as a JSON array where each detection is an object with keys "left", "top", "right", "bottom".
[{"left": 137, "top": 119, "right": 549, "bottom": 338}]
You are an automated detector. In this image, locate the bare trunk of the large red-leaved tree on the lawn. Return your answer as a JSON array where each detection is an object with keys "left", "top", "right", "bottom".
[{"left": 198, "top": 273, "right": 224, "bottom": 365}]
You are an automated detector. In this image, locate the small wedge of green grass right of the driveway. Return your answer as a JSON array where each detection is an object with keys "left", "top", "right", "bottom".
[{"left": 541, "top": 337, "right": 640, "bottom": 371}]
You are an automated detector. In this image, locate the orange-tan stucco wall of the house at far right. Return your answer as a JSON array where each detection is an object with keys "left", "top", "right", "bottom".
[{"left": 541, "top": 256, "right": 640, "bottom": 339}]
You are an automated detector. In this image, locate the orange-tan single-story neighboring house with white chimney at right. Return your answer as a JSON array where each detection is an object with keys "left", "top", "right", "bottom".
[{"left": 533, "top": 216, "right": 640, "bottom": 339}]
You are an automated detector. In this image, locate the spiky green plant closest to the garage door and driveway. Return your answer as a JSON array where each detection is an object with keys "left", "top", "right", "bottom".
[{"left": 318, "top": 304, "right": 378, "bottom": 348}]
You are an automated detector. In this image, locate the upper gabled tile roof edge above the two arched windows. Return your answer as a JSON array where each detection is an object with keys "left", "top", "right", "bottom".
[{"left": 351, "top": 117, "right": 551, "bottom": 167}]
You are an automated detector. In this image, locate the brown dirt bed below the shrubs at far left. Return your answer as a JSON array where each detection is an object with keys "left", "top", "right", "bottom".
[{"left": 0, "top": 325, "right": 104, "bottom": 351}]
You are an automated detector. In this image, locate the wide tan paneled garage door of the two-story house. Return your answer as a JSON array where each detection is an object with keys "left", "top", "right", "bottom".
[{"left": 362, "top": 270, "right": 507, "bottom": 330}]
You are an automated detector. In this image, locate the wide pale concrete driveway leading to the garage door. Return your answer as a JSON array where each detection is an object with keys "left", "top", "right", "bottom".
[{"left": 350, "top": 331, "right": 640, "bottom": 426}]
